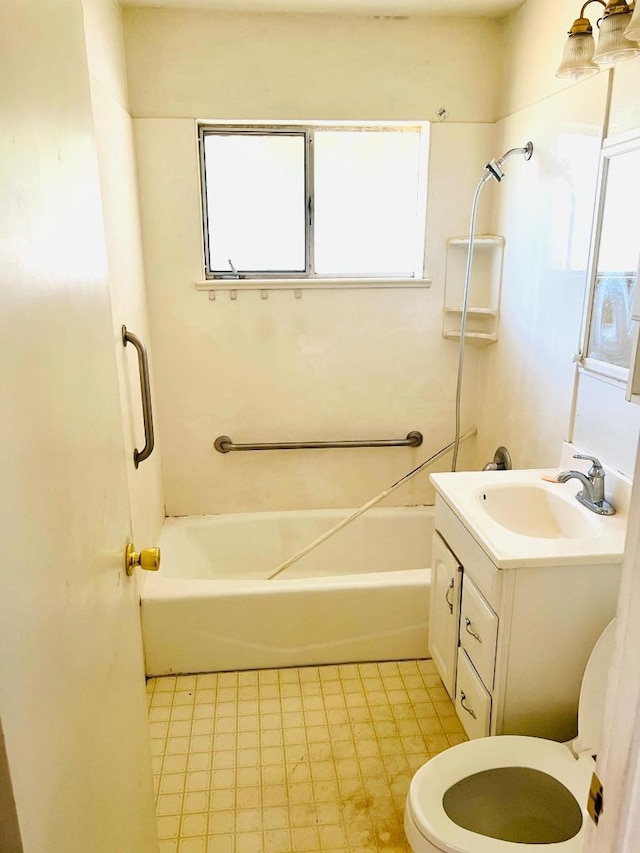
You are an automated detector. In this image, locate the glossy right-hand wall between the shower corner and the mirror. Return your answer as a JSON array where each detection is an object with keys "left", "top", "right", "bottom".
[{"left": 478, "top": 0, "right": 640, "bottom": 475}]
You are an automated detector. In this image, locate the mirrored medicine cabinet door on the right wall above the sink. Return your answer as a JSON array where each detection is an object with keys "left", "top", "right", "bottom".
[{"left": 585, "top": 139, "right": 640, "bottom": 378}]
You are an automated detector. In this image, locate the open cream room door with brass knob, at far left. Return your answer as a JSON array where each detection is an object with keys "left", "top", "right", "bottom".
[{"left": 0, "top": 0, "right": 157, "bottom": 853}]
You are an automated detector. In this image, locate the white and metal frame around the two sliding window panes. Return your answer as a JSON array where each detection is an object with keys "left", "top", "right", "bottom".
[{"left": 197, "top": 121, "right": 429, "bottom": 286}]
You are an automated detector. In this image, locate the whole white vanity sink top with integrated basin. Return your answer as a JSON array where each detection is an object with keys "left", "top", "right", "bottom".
[{"left": 431, "top": 469, "right": 630, "bottom": 569}]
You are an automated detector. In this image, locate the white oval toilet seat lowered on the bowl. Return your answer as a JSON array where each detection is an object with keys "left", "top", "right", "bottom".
[{"left": 407, "top": 735, "right": 594, "bottom": 853}]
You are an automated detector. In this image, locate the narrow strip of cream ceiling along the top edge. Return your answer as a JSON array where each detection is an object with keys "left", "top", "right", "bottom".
[{"left": 120, "top": 0, "right": 523, "bottom": 18}]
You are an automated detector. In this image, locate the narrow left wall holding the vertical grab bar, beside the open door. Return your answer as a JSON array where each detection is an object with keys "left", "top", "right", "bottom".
[{"left": 83, "top": 0, "right": 164, "bottom": 549}]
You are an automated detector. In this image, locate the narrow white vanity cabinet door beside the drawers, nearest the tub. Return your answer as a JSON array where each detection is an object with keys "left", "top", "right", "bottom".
[{"left": 429, "top": 531, "right": 462, "bottom": 699}]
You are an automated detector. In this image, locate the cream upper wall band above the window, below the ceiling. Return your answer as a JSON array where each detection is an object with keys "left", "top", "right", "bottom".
[{"left": 124, "top": 9, "right": 502, "bottom": 122}]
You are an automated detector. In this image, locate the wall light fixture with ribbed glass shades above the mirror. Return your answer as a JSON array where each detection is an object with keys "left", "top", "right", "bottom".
[{"left": 556, "top": 0, "right": 640, "bottom": 80}]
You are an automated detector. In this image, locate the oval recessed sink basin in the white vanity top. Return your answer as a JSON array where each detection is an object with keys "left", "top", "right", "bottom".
[{"left": 476, "top": 483, "right": 599, "bottom": 539}]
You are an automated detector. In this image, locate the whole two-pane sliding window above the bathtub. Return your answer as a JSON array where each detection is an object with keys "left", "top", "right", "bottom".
[{"left": 200, "top": 124, "right": 428, "bottom": 278}]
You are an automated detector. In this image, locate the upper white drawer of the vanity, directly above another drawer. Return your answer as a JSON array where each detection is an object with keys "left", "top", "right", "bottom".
[{"left": 460, "top": 575, "right": 498, "bottom": 690}]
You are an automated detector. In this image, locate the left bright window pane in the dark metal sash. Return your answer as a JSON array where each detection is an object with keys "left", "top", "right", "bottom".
[{"left": 204, "top": 134, "right": 306, "bottom": 272}]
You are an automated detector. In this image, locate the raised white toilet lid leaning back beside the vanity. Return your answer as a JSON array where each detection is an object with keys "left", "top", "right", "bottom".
[{"left": 572, "top": 619, "right": 616, "bottom": 755}]
